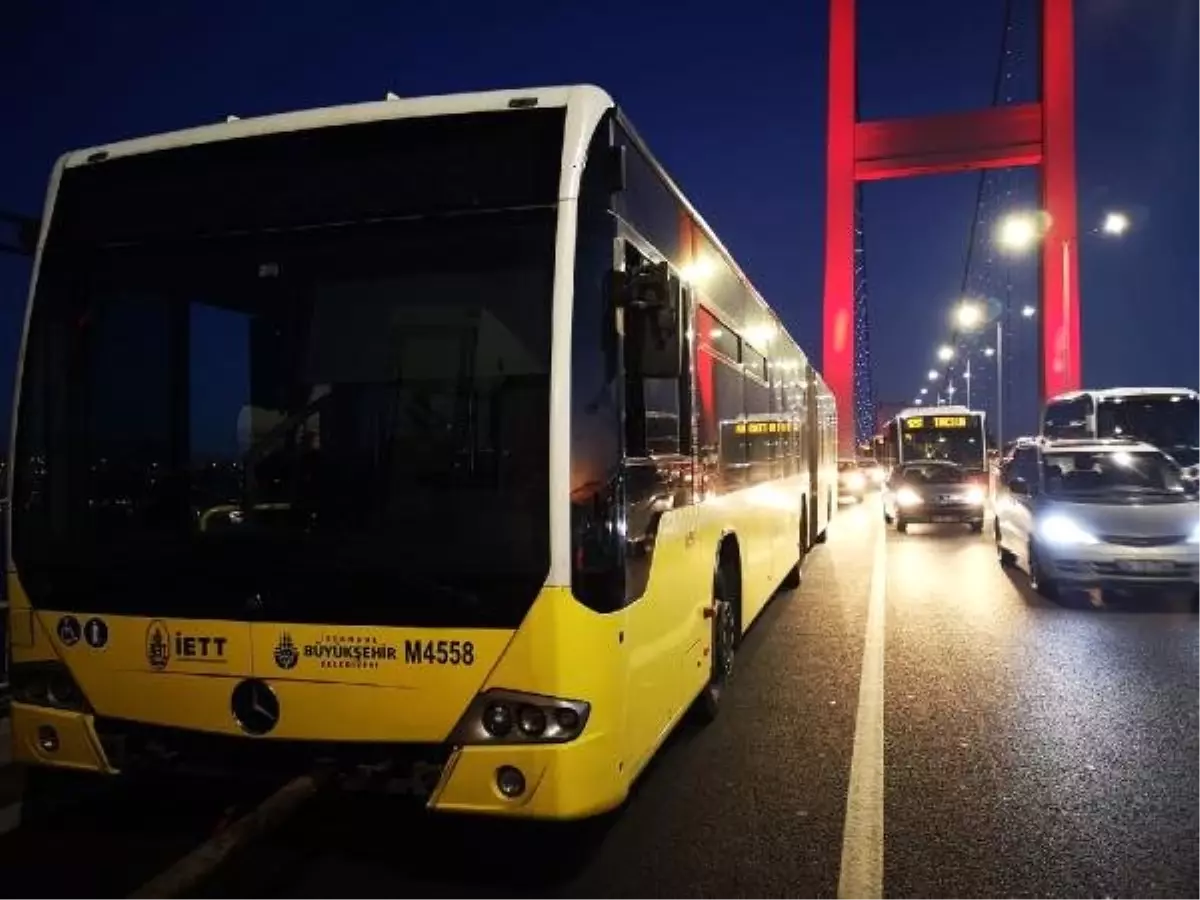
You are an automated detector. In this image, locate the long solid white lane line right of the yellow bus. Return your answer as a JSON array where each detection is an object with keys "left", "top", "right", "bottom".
[{"left": 838, "top": 518, "right": 888, "bottom": 900}]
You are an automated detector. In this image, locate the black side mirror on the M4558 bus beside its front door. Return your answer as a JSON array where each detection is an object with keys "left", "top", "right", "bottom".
[{"left": 612, "top": 263, "right": 684, "bottom": 378}]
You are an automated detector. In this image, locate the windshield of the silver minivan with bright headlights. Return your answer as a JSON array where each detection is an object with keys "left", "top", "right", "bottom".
[{"left": 1042, "top": 450, "right": 1186, "bottom": 498}]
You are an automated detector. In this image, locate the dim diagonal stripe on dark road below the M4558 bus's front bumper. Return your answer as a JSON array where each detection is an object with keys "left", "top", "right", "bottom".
[{"left": 128, "top": 775, "right": 324, "bottom": 900}]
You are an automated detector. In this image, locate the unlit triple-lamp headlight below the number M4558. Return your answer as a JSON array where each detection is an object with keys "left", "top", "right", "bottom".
[{"left": 450, "top": 689, "right": 592, "bottom": 744}]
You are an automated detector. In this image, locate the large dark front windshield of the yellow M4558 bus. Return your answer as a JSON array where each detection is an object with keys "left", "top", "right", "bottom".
[{"left": 13, "top": 111, "right": 559, "bottom": 626}]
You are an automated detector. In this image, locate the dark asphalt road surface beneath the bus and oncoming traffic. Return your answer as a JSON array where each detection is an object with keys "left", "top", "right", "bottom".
[{"left": 0, "top": 500, "right": 1200, "bottom": 900}]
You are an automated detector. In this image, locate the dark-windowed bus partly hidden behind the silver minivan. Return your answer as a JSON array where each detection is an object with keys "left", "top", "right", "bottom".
[{"left": 1042, "top": 388, "right": 1200, "bottom": 478}]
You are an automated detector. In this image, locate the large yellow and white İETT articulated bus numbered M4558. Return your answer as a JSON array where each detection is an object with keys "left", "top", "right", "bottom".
[{"left": 8, "top": 86, "right": 838, "bottom": 820}]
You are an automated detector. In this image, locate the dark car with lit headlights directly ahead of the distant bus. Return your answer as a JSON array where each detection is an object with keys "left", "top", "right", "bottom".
[{"left": 883, "top": 460, "right": 986, "bottom": 533}]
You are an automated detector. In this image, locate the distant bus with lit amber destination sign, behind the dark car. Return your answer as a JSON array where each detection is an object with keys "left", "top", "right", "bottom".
[{"left": 881, "top": 406, "right": 988, "bottom": 476}]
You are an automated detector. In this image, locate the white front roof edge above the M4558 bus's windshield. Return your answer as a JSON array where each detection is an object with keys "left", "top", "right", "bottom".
[{"left": 65, "top": 85, "right": 604, "bottom": 167}]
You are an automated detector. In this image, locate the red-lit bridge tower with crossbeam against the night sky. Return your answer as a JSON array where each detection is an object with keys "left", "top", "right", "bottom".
[{"left": 822, "top": 0, "right": 1080, "bottom": 454}]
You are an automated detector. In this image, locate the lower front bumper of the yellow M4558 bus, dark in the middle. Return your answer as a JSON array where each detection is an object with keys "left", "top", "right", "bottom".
[{"left": 12, "top": 703, "right": 628, "bottom": 820}]
